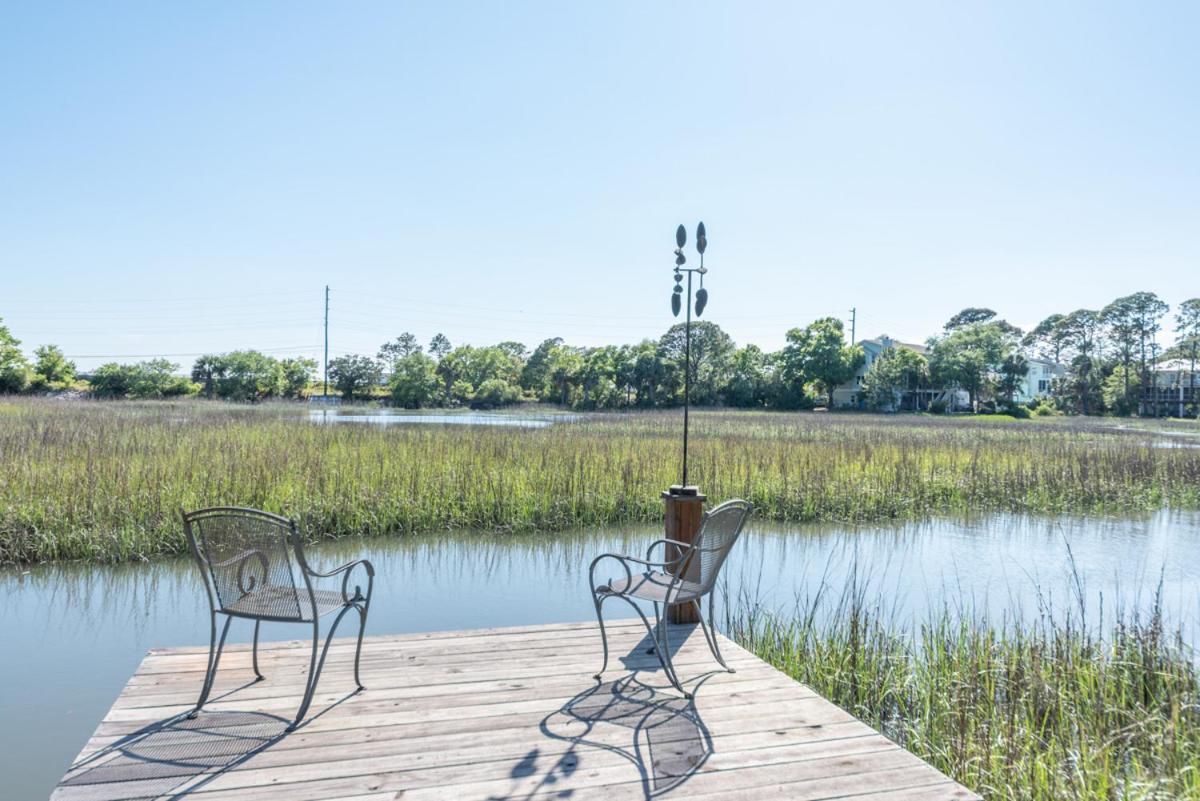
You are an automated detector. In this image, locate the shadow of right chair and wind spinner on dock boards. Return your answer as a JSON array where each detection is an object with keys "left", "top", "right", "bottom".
[{"left": 496, "top": 627, "right": 724, "bottom": 800}]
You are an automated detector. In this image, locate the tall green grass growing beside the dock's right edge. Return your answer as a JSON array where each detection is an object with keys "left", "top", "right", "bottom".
[{"left": 728, "top": 582, "right": 1200, "bottom": 801}]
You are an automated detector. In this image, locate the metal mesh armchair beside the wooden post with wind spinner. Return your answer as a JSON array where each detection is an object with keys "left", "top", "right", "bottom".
[{"left": 588, "top": 500, "right": 754, "bottom": 698}]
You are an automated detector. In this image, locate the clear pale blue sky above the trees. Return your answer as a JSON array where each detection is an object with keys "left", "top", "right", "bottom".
[{"left": 0, "top": 1, "right": 1200, "bottom": 367}]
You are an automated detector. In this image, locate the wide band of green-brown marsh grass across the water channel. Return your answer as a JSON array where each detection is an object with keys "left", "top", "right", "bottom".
[{"left": 0, "top": 399, "right": 1200, "bottom": 562}]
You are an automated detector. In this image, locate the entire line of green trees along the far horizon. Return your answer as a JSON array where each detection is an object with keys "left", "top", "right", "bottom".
[{"left": 0, "top": 287, "right": 1200, "bottom": 415}]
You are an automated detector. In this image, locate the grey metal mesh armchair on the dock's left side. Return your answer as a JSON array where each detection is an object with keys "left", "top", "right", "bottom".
[{"left": 184, "top": 506, "right": 374, "bottom": 730}]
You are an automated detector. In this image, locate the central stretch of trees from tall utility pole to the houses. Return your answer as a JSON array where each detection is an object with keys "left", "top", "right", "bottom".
[{"left": 316, "top": 318, "right": 863, "bottom": 409}]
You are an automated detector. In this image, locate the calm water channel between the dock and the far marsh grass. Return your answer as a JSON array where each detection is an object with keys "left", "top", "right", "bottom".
[{"left": 0, "top": 512, "right": 1200, "bottom": 799}]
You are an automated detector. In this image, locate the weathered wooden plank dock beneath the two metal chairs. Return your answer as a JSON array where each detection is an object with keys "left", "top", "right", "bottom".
[{"left": 52, "top": 620, "right": 979, "bottom": 801}]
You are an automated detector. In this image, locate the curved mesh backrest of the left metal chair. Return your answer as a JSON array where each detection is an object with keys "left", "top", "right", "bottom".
[{"left": 184, "top": 506, "right": 311, "bottom": 620}]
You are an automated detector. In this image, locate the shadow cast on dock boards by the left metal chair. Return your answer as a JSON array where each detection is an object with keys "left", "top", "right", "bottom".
[{"left": 59, "top": 682, "right": 355, "bottom": 799}]
